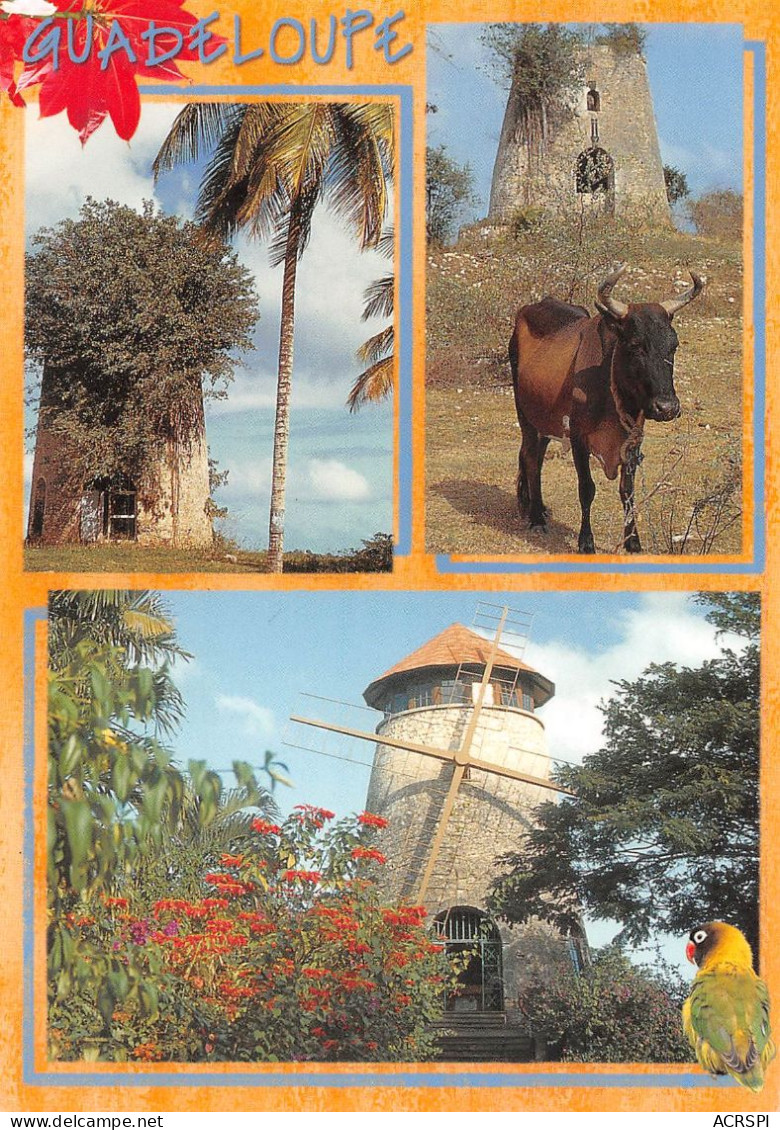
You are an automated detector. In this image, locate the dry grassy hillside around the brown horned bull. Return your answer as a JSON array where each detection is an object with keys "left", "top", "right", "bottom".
[{"left": 426, "top": 217, "right": 743, "bottom": 556}]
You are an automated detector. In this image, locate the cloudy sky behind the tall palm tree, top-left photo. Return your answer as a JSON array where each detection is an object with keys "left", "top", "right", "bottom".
[{"left": 25, "top": 103, "right": 393, "bottom": 553}]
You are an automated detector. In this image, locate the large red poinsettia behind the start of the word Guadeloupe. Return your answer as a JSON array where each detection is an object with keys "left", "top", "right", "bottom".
[{"left": 19, "top": 0, "right": 224, "bottom": 142}]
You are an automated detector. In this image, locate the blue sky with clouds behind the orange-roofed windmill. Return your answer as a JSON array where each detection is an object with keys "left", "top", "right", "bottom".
[{"left": 154, "top": 591, "right": 728, "bottom": 970}]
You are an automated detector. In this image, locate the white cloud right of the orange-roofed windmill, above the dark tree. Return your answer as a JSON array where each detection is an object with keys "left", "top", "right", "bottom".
[{"left": 527, "top": 593, "right": 728, "bottom": 762}]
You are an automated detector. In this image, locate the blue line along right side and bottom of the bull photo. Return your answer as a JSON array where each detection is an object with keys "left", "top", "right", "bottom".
[{"left": 436, "top": 40, "right": 766, "bottom": 574}]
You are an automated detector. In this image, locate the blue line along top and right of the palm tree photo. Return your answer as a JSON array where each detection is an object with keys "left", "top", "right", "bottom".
[{"left": 139, "top": 84, "right": 414, "bottom": 557}]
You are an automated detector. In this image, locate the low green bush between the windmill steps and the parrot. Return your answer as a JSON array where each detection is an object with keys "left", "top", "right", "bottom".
[{"left": 520, "top": 946, "right": 692, "bottom": 1063}]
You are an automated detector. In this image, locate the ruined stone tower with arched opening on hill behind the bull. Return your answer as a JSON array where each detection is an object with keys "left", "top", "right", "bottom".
[{"left": 489, "top": 43, "right": 671, "bottom": 226}]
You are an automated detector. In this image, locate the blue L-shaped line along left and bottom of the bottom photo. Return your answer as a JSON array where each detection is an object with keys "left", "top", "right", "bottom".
[{"left": 21, "top": 608, "right": 738, "bottom": 1090}]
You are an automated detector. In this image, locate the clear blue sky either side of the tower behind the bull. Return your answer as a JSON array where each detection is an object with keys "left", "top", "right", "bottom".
[{"left": 426, "top": 24, "right": 743, "bottom": 220}]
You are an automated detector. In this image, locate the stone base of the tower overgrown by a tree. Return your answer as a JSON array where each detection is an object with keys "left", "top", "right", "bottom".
[{"left": 27, "top": 367, "right": 213, "bottom": 548}]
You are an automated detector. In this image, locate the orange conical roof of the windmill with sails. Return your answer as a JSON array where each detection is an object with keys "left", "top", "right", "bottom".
[{"left": 363, "top": 624, "right": 555, "bottom": 706}]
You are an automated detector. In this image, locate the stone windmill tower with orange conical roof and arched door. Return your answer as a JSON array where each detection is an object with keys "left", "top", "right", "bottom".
[{"left": 295, "top": 606, "right": 587, "bottom": 1062}]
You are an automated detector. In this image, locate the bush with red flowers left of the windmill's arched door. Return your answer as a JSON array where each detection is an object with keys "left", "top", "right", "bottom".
[{"left": 50, "top": 806, "right": 452, "bottom": 1061}]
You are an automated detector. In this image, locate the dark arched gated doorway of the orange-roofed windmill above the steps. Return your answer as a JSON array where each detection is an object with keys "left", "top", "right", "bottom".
[{"left": 433, "top": 906, "right": 504, "bottom": 1012}]
